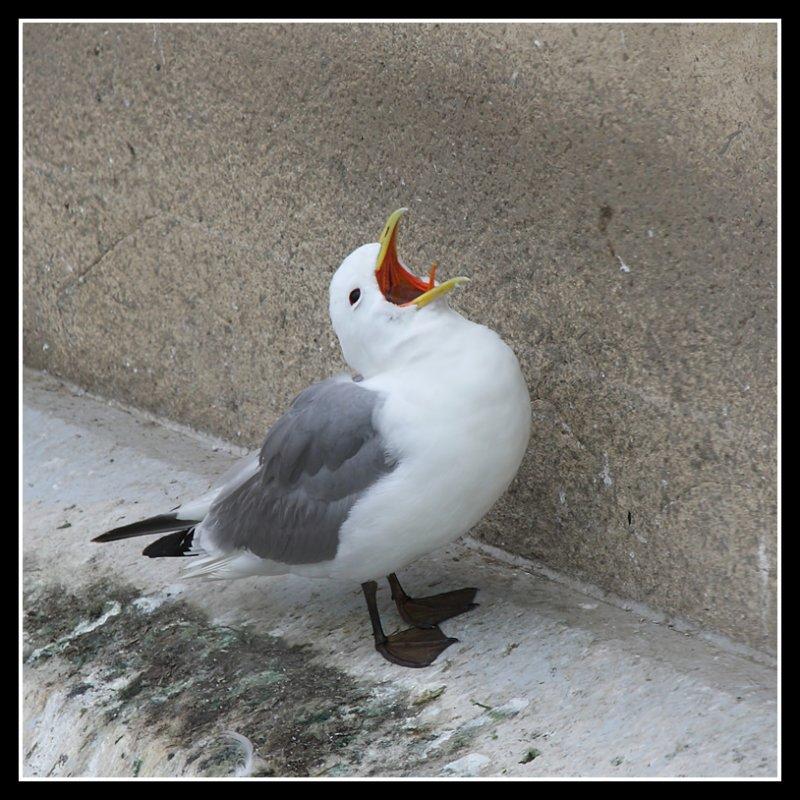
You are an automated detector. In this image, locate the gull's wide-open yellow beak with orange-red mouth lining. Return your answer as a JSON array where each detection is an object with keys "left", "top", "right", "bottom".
[{"left": 375, "top": 208, "right": 469, "bottom": 308}]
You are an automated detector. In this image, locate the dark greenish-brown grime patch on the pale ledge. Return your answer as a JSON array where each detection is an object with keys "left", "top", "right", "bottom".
[{"left": 24, "top": 581, "right": 432, "bottom": 776}]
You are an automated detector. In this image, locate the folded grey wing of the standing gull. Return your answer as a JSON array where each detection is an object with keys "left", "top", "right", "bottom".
[{"left": 203, "top": 378, "right": 395, "bottom": 564}]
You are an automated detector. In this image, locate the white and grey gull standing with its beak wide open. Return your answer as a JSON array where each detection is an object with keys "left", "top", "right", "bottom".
[{"left": 92, "top": 208, "right": 531, "bottom": 667}]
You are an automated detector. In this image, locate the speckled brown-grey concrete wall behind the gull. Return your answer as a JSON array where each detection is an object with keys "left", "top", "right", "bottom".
[{"left": 24, "top": 24, "right": 776, "bottom": 650}]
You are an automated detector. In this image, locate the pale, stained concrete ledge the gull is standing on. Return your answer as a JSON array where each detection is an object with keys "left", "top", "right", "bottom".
[{"left": 23, "top": 375, "right": 779, "bottom": 777}]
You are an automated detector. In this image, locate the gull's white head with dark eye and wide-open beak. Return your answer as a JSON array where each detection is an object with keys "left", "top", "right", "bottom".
[{"left": 329, "top": 208, "right": 468, "bottom": 378}]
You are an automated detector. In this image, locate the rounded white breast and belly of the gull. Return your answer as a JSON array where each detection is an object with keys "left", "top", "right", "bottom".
[{"left": 329, "top": 317, "right": 531, "bottom": 582}]
